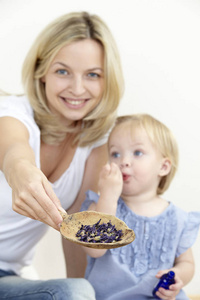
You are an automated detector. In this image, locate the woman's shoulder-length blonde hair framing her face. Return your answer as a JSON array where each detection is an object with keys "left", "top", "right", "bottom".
[{"left": 22, "top": 12, "right": 124, "bottom": 146}]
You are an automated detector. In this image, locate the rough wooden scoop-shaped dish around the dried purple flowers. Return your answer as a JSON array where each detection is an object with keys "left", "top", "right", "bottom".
[{"left": 60, "top": 211, "right": 135, "bottom": 249}]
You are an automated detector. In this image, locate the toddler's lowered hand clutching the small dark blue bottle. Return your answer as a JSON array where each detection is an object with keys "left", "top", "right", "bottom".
[{"left": 156, "top": 270, "right": 183, "bottom": 300}]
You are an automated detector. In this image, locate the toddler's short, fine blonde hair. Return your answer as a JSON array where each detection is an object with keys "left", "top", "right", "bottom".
[{"left": 108, "top": 114, "right": 179, "bottom": 195}]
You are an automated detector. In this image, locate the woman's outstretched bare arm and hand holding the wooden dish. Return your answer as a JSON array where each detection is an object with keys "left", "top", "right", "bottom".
[{"left": 0, "top": 117, "right": 62, "bottom": 230}]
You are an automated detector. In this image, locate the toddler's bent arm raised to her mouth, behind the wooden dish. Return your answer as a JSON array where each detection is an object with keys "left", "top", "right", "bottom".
[{"left": 83, "top": 163, "right": 123, "bottom": 257}]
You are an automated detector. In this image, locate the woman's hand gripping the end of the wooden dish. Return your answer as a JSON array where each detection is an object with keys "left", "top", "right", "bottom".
[{"left": 9, "top": 160, "right": 63, "bottom": 230}]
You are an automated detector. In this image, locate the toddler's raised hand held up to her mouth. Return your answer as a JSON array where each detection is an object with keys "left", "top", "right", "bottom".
[{"left": 99, "top": 163, "right": 123, "bottom": 200}]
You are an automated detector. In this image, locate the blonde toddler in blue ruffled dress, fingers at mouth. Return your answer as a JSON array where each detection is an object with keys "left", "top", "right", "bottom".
[{"left": 83, "top": 114, "right": 200, "bottom": 300}]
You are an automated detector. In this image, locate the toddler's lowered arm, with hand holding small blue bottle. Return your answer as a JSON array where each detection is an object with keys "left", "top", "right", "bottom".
[{"left": 156, "top": 248, "right": 194, "bottom": 300}]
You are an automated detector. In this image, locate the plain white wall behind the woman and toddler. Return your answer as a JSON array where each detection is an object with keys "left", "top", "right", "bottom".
[{"left": 0, "top": 0, "right": 200, "bottom": 294}]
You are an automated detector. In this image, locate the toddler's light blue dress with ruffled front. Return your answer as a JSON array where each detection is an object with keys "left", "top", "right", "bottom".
[{"left": 81, "top": 191, "right": 200, "bottom": 300}]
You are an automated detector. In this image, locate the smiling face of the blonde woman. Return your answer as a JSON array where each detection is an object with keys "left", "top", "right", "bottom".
[{"left": 42, "top": 39, "right": 104, "bottom": 125}]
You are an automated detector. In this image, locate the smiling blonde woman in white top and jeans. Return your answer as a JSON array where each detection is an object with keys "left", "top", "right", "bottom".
[{"left": 0, "top": 12, "right": 123, "bottom": 300}]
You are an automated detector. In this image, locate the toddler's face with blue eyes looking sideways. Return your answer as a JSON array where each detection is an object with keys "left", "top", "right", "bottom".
[{"left": 109, "top": 122, "right": 164, "bottom": 196}]
